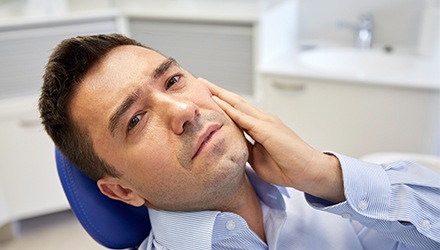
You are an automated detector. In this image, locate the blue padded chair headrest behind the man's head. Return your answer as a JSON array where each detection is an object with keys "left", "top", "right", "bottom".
[{"left": 55, "top": 148, "right": 151, "bottom": 249}]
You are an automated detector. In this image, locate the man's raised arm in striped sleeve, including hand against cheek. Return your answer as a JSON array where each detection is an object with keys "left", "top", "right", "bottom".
[{"left": 205, "top": 81, "right": 440, "bottom": 247}]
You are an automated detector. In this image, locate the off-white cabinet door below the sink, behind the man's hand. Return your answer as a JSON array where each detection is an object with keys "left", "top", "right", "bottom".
[{"left": 263, "top": 76, "right": 440, "bottom": 157}]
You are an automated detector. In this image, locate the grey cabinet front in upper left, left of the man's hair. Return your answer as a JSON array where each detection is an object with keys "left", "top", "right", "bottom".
[{"left": 0, "top": 17, "right": 117, "bottom": 99}]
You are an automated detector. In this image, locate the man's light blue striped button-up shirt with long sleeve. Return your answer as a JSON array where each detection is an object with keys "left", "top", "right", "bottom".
[{"left": 140, "top": 154, "right": 440, "bottom": 250}]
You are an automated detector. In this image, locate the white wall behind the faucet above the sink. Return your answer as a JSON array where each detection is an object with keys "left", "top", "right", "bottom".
[{"left": 299, "top": 0, "right": 425, "bottom": 46}]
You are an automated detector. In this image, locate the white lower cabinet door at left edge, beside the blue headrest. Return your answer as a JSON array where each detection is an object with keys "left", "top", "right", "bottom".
[{"left": 0, "top": 102, "right": 69, "bottom": 221}]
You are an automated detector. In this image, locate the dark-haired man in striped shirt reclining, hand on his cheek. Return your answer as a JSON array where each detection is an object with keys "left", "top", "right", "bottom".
[{"left": 40, "top": 34, "right": 440, "bottom": 249}]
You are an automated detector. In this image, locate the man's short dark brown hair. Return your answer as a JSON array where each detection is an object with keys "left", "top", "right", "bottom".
[{"left": 39, "top": 34, "right": 151, "bottom": 181}]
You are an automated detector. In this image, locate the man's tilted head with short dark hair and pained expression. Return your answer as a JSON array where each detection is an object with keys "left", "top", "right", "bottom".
[{"left": 40, "top": 35, "right": 248, "bottom": 210}]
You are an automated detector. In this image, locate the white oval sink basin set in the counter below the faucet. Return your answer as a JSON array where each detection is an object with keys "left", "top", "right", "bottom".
[{"left": 299, "top": 48, "right": 415, "bottom": 74}]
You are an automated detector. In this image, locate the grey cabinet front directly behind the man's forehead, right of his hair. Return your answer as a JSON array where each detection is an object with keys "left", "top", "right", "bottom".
[{"left": 129, "top": 18, "right": 254, "bottom": 96}]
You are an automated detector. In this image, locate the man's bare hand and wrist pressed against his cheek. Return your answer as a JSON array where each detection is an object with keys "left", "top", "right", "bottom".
[{"left": 199, "top": 78, "right": 344, "bottom": 202}]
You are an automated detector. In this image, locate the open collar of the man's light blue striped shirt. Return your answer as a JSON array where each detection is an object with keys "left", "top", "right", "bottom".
[{"left": 148, "top": 166, "right": 288, "bottom": 249}]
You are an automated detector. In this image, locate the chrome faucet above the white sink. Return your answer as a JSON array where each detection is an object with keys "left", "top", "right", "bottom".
[{"left": 336, "top": 13, "right": 373, "bottom": 49}]
